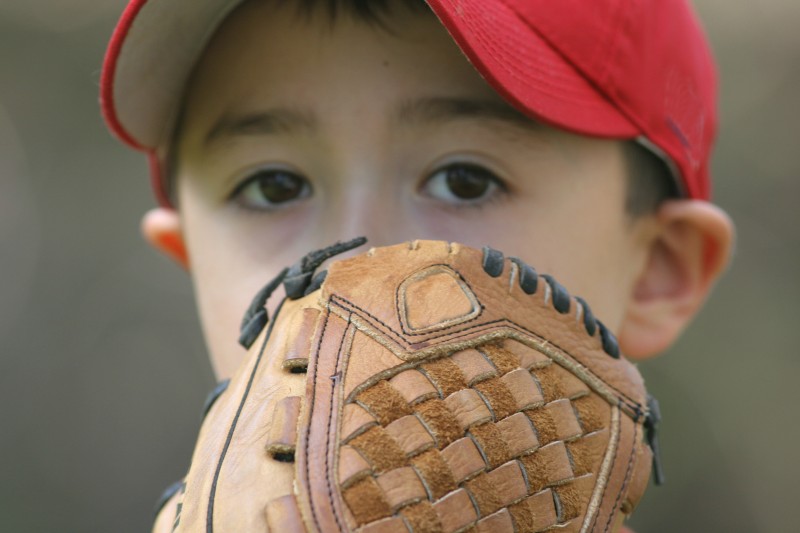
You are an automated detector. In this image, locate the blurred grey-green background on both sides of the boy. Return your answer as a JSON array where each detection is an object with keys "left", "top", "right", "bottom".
[{"left": 0, "top": 0, "right": 800, "bottom": 533}]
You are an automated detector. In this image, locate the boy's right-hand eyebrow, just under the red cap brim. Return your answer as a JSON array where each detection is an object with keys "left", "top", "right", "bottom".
[{"left": 397, "top": 97, "right": 542, "bottom": 130}]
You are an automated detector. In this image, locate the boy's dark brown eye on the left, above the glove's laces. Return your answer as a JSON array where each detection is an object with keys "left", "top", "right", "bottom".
[{"left": 233, "top": 169, "right": 311, "bottom": 209}]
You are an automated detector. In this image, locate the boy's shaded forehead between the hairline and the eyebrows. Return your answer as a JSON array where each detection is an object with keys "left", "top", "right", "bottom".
[{"left": 182, "top": 2, "right": 552, "bottom": 155}]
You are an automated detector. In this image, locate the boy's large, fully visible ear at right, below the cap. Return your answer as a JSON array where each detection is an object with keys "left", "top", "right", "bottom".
[{"left": 619, "top": 200, "right": 734, "bottom": 359}]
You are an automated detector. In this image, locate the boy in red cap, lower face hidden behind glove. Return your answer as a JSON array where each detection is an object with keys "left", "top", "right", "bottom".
[{"left": 102, "top": 0, "right": 733, "bottom": 528}]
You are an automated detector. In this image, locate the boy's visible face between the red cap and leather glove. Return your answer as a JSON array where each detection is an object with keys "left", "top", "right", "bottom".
[{"left": 176, "top": 1, "right": 651, "bottom": 376}]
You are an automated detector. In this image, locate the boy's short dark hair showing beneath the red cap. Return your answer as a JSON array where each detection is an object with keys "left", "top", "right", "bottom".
[{"left": 166, "top": 0, "right": 680, "bottom": 214}]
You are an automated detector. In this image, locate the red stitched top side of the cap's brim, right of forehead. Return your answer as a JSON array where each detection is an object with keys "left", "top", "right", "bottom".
[{"left": 428, "top": 0, "right": 641, "bottom": 138}]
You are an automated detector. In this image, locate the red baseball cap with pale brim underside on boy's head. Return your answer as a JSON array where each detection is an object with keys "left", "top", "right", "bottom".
[{"left": 100, "top": 0, "right": 717, "bottom": 205}]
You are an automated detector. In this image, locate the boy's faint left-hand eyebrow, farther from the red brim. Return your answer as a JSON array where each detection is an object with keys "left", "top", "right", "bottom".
[{"left": 205, "top": 107, "right": 318, "bottom": 145}]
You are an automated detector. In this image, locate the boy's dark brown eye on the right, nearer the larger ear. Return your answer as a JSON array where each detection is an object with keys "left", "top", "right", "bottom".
[{"left": 422, "top": 163, "right": 505, "bottom": 204}]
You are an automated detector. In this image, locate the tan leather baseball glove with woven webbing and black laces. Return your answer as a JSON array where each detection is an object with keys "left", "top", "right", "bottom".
[{"left": 156, "top": 239, "right": 661, "bottom": 533}]
